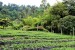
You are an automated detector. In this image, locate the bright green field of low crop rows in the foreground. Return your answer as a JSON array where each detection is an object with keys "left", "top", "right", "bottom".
[{"left": 0, "top": 30, "right": 75, "bottom": 50}]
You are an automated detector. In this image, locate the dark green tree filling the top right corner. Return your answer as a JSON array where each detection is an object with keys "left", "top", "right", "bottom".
[{"left": 63, "top": 0, "right": 75, "bottom": 16}]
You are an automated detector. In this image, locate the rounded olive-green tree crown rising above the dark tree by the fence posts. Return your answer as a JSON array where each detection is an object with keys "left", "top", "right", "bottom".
[{"left": 51, "top": 3, "right": 68, "bottom": 18}]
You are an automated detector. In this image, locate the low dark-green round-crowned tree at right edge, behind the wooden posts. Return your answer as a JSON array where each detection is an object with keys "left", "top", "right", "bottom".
[{"left": 59, "top": 16, "right": 75, "bottom": 35}]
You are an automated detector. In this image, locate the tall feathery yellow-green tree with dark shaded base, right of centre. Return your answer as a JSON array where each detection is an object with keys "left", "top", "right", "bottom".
[{"left": 42, "top": 6, "right": 60, "bottom": 32}]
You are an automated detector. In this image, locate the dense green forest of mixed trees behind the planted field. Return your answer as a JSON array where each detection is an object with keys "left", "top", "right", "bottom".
[{"left": 0, "top": 0, "right": 75, "bottom": 35}]
